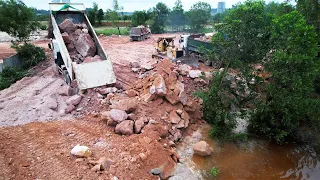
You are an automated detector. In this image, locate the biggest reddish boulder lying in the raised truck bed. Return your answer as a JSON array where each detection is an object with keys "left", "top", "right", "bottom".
[{"left": 75, "top": 34, "right": 97, "bottom": 57}]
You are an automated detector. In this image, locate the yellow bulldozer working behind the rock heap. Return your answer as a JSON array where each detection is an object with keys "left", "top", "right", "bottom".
[{"left": 152, "top": 36, "right": 183, "bottom": 60}]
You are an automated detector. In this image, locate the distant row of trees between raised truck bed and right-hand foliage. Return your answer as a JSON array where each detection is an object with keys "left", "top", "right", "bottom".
[{"left": 88, "top": 0, "right": 212, "bottom": 33}]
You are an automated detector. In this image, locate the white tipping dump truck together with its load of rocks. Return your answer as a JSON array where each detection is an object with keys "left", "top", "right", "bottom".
[{"left": 49, "top": 3, "right": 116, "bottom": 90}]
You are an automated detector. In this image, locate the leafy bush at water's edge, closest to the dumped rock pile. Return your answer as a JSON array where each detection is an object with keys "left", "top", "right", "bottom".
[{"left": 198, "top": 71, "right": 250, "bottom": 140}]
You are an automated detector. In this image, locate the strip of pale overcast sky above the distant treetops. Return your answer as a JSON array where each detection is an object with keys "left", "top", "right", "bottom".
[{"left": 22, "top": 0, "right": 284, "bottom": 12}]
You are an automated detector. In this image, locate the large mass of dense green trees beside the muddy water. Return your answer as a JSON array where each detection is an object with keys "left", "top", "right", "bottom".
[{"left": 198, "top": 1, "right": 320, "bottom": 144}]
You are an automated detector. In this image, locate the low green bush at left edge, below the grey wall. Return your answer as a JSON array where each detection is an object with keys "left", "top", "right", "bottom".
[{"left": 0, "top": 67, "right": 27, "bottom": 90}]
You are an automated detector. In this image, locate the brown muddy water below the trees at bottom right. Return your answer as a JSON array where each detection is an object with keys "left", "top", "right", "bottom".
[{"left": 180, "top": 126, "right": 320, "bottom": 180}]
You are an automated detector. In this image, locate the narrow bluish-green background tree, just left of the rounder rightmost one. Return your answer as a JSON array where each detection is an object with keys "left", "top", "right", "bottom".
[{"left": 169, "top": 0, "right": 186, "bottom": 30}]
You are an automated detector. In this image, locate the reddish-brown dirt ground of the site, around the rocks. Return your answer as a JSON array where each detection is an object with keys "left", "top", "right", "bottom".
[{"left": 0, "top": 34, "right": 209, "bottom": 180}]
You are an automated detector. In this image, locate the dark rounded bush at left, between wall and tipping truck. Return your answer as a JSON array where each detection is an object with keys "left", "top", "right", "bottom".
[{"left": 13, "top": 43, "right": 45, "bottom": 69}]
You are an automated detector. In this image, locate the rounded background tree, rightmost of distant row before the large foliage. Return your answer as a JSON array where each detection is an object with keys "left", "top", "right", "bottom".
[{"left": 186, "top": 2, "right": 211, "bottom": 32}]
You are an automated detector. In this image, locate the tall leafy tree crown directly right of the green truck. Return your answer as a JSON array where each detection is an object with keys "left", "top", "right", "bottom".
[{"left": 214, "top": 1, "right": 271, "bottom": 63}]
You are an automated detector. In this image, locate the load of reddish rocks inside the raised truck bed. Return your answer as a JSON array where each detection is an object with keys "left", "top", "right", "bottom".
[{"left": 59, "top": 19, "right": 101, "bottom": 64}]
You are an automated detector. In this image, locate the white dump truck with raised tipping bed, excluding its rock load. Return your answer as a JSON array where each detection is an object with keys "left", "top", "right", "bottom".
[{"left": 49, "top": 3, "right": 116, "bottom": 90}]
